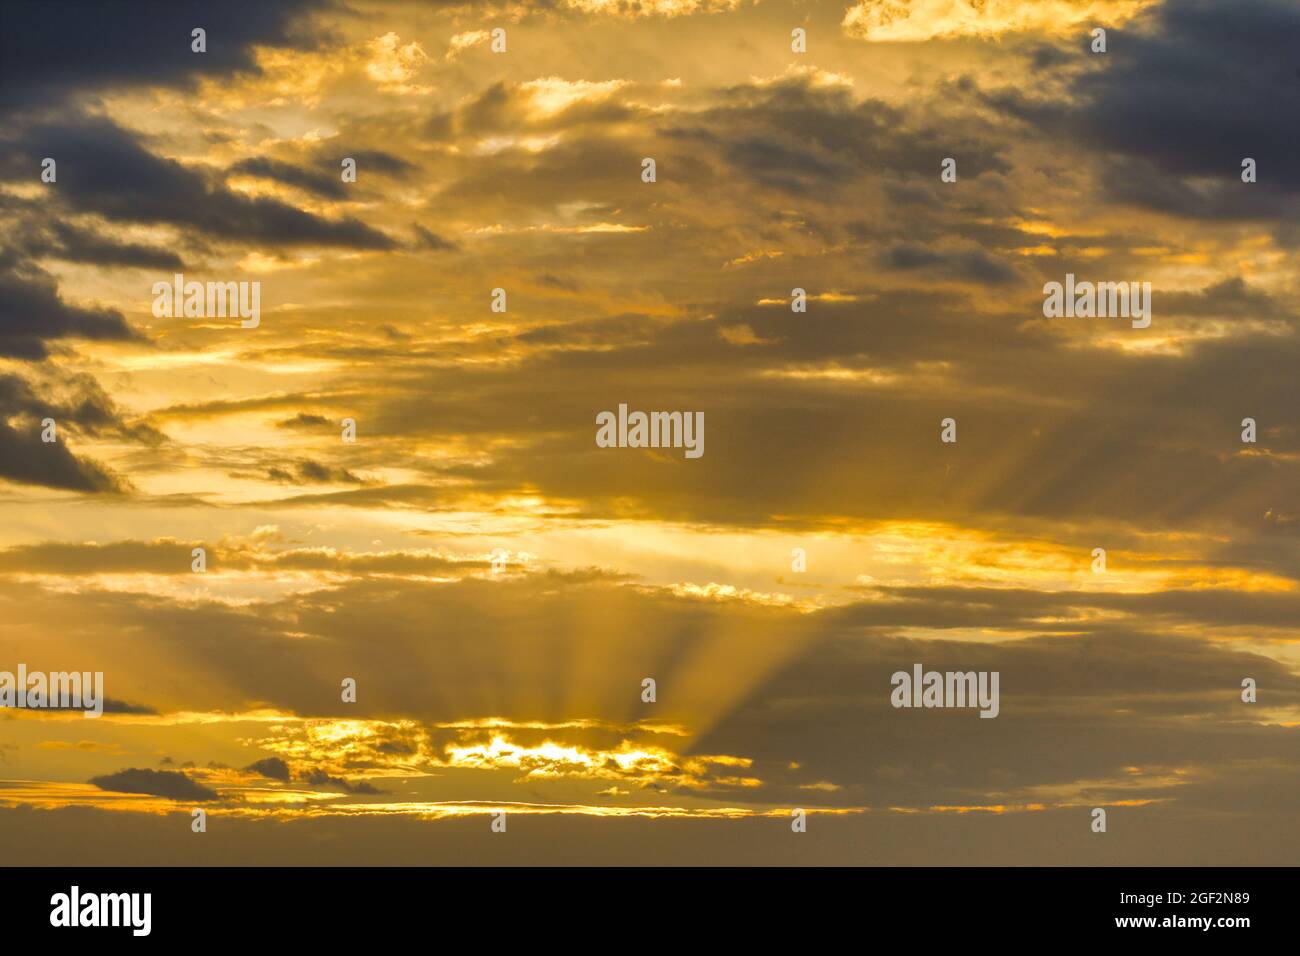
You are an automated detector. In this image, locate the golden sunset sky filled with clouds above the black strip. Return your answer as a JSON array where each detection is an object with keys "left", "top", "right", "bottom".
[{"left": 0, "top": 0, "right": 1300, "bottom": 865}]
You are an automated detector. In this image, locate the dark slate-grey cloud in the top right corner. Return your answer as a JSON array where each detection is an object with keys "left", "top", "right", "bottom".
[{"left": 963, "top": 0, "right": 1300, "bottom": 221}]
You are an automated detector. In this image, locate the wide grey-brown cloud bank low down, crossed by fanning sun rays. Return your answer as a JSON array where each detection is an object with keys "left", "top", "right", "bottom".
[{"left": 5, "top": 578, "right": 1300, "bottom": 808}]
